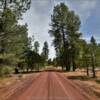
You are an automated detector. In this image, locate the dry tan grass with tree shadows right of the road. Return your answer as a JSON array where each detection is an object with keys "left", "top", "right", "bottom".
[{"left": 64, "top": 70, "right": 100, "bottom": 96}]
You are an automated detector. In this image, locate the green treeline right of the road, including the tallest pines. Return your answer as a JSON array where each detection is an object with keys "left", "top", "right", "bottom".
[{"left": 49, "top": 3, "right": 100, "bottom": 77}]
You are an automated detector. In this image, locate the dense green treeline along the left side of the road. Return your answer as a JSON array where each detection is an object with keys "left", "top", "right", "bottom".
[{"left": 0, "top": 0, "right": 49, "bottom": 75}]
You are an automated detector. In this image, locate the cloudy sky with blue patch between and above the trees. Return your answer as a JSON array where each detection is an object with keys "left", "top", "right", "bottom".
[{"left": 19, "top": 0, "right": 100, "bottom": 58}]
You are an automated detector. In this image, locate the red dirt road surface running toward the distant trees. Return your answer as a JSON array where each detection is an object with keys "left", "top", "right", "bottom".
[{"left": 4, "top": 72, "right": 100, "bottom": 100}]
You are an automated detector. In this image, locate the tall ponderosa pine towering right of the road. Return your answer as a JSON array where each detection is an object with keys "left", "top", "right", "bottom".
[{"left": 49, "top": 3, "right": 81, "bottom": 71}]
